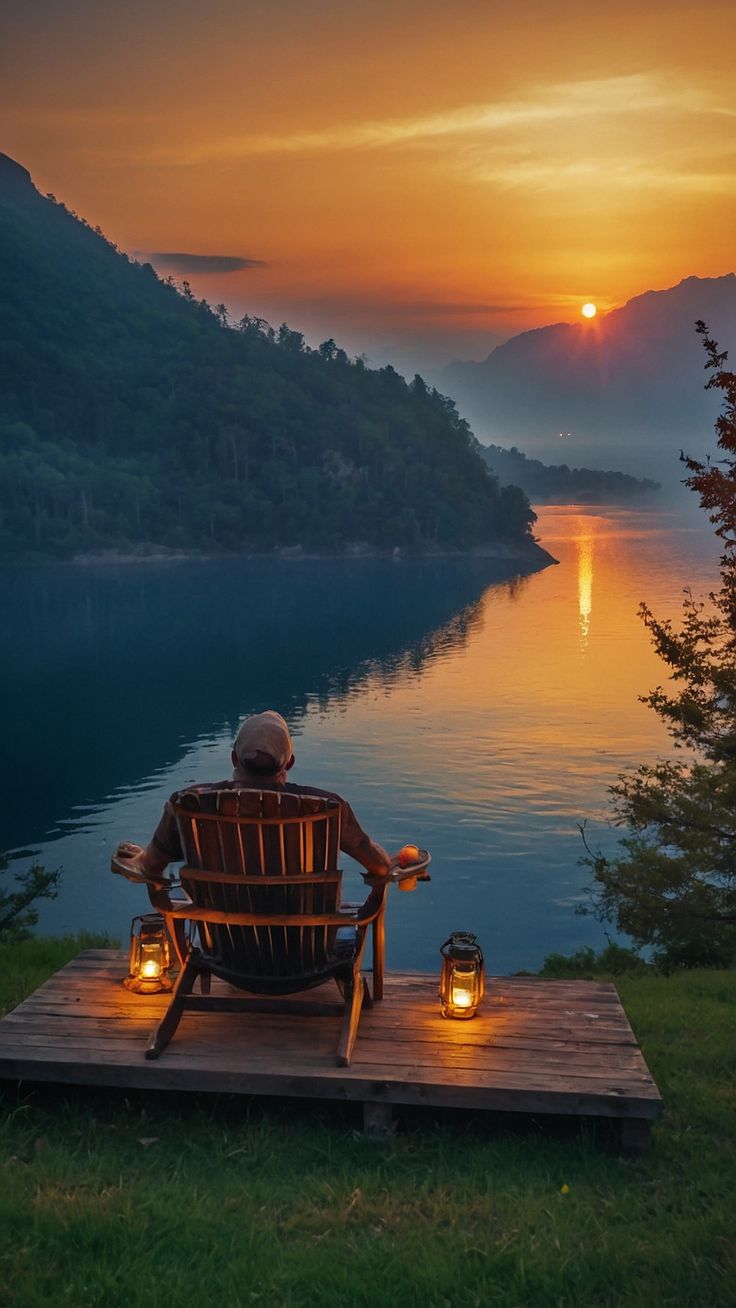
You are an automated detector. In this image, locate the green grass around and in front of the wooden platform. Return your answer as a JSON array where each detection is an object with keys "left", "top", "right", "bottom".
[{"left": 0, "top": 942, "right": 736, "bottom": 1308}]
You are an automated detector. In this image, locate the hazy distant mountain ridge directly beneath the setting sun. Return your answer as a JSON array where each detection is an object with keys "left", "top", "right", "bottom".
[{"left": 441, "top": 272, "right": 736, "bottom": 477}]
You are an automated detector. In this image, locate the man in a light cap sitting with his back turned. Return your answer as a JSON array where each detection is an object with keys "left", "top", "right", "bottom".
[{"left": 116, "top": 709, "right": 391, "bottom": 882}]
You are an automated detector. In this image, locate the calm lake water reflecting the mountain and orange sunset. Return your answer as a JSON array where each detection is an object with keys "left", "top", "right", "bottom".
[{"left": 0, "top": 506, "right": 718, "bottom": 972}]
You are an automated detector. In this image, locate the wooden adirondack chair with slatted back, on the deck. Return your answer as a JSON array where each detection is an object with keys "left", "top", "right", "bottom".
[{"left": 124, "top": 790, "right": 387, "bottom": 1066}]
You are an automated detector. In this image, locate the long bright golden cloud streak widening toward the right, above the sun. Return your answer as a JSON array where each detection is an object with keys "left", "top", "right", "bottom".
[{"left": 147, "top": 71, "right": 736, "bottom": 208}]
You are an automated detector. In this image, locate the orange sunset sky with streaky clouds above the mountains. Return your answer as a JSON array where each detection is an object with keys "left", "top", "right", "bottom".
[{"left": 0, "top": 0, "right": 736, "bottom": 371}]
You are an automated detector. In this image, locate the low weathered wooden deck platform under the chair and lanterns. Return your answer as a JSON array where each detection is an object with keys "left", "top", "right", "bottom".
[{"left": 0, "top": 950, "right": 661, "bottom": 1150}]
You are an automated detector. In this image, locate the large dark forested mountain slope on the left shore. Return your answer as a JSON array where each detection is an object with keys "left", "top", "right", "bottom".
[{"left": 0, "top": 156, "right": 533, "bottom": 557}]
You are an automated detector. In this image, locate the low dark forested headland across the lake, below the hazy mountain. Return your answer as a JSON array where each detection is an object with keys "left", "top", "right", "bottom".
[{"left": 481, "top": 445, "right": 660, "bottom": 504}]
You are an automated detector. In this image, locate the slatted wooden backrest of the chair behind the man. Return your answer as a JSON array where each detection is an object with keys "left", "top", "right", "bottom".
[{"left": 173, "top": 789, "right": 341, "bottom": 980}]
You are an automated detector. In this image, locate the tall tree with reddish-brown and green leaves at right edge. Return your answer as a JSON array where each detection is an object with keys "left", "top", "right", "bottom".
[{"left": 586, "top": 322, "right": 736, "bottom": 965}]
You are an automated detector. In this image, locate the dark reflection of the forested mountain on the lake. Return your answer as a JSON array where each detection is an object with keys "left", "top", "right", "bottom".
[{"left": 0, "top": 557, "right": 541, "bottom": 849}]
